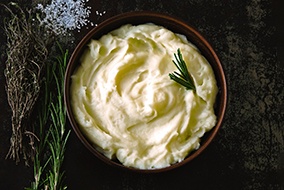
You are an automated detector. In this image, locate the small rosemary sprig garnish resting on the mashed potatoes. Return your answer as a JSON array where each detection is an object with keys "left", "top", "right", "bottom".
[{"left": 169, "top": 49, "right": 195, "bottom": 91}]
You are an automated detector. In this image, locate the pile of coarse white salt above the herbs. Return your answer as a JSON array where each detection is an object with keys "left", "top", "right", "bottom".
[{"left": 37, "top": 0, "right": 93, "bottom": 35}]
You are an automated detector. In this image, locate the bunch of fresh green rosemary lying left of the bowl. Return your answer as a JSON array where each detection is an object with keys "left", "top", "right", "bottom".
[{"left": 26, "top": 45, "right": 70, "bottom": 190}]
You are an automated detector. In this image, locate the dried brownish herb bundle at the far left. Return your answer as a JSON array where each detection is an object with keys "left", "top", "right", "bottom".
[{"left": 4, "top": 4, "right": 52, "bottom": 164}]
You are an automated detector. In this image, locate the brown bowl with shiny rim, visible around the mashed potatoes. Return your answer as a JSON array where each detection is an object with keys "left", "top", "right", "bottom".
[{"left": 64, "top": 11, "right": 227, "bottom": 172}]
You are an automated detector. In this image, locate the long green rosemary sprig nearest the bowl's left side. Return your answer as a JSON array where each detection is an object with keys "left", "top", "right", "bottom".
[{"left": 45, "top": 46, "right": 70, "bottom": 190}]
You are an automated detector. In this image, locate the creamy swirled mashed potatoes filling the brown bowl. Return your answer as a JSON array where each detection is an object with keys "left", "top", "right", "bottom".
[{"left": 71, "top": 24, "right": 217, "bottom": 169}]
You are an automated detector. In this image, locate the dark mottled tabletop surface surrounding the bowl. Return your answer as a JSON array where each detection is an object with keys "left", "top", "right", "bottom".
[{"left": 0, "top": 0, "right": 284, "bottom": 190}]
